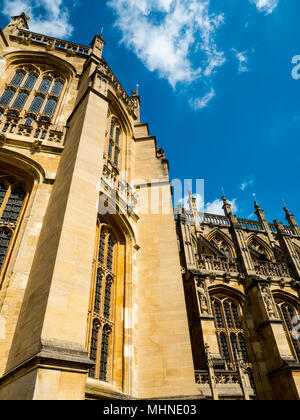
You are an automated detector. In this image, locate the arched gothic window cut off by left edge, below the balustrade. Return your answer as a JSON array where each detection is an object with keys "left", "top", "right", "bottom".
[{"left": 0, "top": 171, "right": 28, "bottom": 274}]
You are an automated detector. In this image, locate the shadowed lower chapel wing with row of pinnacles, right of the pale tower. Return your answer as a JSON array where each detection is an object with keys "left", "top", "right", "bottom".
[{"left": 176, "top": 194, "right": 300, "bottom": 400}]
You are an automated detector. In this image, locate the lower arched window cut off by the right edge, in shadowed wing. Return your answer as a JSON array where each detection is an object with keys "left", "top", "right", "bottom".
[{"left": 276, "top": 299, "right": 300, "bottom": 362}]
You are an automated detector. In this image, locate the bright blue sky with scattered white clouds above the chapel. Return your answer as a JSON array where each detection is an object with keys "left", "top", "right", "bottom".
[{"left": 0, "top": 0, "right": 300, "bottom": 225}]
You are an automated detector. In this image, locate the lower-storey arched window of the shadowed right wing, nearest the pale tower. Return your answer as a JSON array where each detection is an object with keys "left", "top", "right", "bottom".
[{"left": 212, "top": 297, "right": 251, "bottom": 369}]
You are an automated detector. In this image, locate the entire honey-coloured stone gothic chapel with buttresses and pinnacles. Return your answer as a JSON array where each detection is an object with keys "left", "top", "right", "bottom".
[{"left": 0, "top": 13, "right": 300, "bottom": 400}]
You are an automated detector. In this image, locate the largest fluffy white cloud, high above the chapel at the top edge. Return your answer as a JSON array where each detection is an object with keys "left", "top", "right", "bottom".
[{"left": 108, "top": 0, "right": 225, "bottom": 88}]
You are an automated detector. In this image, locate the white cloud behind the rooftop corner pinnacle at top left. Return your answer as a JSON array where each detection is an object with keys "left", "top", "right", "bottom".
[{"left": 1, "top": 0, "right": 73, "bottom": 38}]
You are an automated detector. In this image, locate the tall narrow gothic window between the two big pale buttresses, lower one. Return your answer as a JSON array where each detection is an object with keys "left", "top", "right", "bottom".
[{"left": 89, "top": 224, "right": 117, "bottom": 382}]
